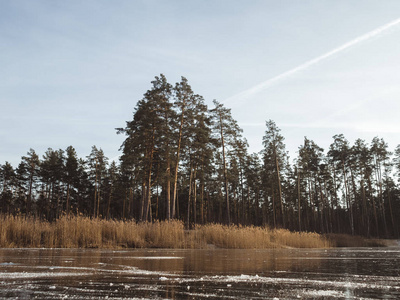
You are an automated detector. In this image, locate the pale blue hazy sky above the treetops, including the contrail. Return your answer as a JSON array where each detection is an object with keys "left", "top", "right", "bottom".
[{"left": 0, "top": 0, "right": 400, "bottom": 167}]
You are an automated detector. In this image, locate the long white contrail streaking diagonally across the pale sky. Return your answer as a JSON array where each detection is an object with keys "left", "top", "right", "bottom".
[{"left": 222, "top": 18, "right": 400, "bottom": 103}]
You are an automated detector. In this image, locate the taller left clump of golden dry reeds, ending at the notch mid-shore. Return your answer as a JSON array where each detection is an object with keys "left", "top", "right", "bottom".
[{"left": 0, "top": 216, "right": 185, "bottom": 248}]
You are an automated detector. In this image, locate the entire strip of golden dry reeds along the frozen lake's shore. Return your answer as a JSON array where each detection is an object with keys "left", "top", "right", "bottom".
[{"left": 0, "top": 215, "right": 332, "bottom": 249}]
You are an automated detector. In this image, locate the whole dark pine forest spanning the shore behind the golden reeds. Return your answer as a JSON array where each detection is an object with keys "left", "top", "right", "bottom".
[{"left": 0, "top": 74, "right": 400, "bottom": 238}]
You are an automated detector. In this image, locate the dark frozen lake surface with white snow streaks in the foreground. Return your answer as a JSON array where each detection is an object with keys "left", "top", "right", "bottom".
[{"left": 0, "top": 248, "right": 400, "bottom": 299}]
